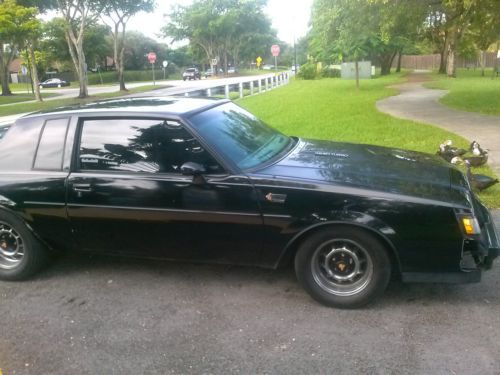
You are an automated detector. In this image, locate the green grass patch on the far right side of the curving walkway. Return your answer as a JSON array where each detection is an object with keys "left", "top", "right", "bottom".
[{"left": 425, "top": 69, "right": 500, "bottom": 115}]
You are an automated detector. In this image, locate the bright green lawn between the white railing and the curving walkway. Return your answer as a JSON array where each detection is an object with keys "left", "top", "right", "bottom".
[{"left": 238, "top": 74, "right": 500, "bottom": 208}]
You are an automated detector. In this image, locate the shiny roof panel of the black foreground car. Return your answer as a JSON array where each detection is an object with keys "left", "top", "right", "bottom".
[{"left": 23, "top": 96, "right": 229, "bottom": 118}]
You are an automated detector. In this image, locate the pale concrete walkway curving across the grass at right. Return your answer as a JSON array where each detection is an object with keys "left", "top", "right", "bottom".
[{"left": 377, "top": 71, "right": 500, "bottom": 176}]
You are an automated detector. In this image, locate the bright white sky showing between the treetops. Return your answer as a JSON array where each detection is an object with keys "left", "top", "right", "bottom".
[{"left": 127, "top": 0, "right": 313, "bottom": 44}]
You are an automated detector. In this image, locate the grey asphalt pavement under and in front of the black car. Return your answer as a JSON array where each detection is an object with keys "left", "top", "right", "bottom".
[{"left": 0, "top": 212, "right": 500, "bottom": 375}]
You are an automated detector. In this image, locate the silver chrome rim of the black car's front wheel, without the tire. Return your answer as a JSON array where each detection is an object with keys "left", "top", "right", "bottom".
[{"left": 311, "top": 239, "right": 373, "bottom": 296}]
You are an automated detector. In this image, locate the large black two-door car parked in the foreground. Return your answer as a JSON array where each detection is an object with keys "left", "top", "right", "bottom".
[{"left": 0, "top": 98, "right": 499, "bottom": 307}]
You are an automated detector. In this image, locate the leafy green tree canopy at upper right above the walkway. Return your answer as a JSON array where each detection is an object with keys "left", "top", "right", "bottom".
[{"left": 309, "top": 0, "right": 500, "bottom": 76}]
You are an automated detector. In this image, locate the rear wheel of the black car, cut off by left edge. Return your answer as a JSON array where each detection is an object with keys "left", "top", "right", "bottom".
[{"left": 0, "top": 211, "right": 48, "bottom": 280}]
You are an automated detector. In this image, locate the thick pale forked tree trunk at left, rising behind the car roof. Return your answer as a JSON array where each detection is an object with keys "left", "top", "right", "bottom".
[{"left": 57, "top": 0, "right": 99, "bottom": 98}]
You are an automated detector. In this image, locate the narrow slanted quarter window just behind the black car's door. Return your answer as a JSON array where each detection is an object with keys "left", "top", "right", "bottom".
[{"left": 33, "top": 118, "right": 69, "bottom": 170}]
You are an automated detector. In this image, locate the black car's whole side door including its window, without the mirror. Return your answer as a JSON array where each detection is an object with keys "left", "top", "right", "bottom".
[{"left": 68, "top": 117, "right": 263, "bottom": 264}]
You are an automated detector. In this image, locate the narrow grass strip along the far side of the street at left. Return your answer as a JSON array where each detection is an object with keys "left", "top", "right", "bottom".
[{"left": 0, "top": 85, "right": 170, "bottom": 116}]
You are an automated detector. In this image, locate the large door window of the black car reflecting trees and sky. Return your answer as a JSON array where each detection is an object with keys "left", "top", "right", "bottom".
[{"left": 79, "top": 118, "right": 222, "bottom": 173}]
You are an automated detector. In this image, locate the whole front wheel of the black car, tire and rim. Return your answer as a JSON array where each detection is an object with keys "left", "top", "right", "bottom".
[{"left": 295, "top": 227, "right": 391, "bottom": 309}]
